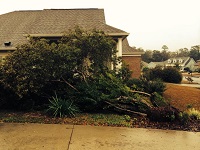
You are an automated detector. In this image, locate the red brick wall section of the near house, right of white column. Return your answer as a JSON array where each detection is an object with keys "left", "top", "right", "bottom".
[{"left": 122, "top": 56, "right": 141, "bottom": 78}]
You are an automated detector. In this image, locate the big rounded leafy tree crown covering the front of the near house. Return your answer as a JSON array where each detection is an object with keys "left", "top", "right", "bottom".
[{"left": 2, "top": 27, "right": 117, "bottom": 97}]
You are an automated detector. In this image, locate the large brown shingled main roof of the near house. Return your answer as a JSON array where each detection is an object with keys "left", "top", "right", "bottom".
[{"left": 0, "top": 9, "right": 128, "bottom": 49}]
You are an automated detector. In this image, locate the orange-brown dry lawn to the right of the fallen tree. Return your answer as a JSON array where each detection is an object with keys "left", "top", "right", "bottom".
[{"left": 164, "top": 84, "right": 200, "bottom": 111}]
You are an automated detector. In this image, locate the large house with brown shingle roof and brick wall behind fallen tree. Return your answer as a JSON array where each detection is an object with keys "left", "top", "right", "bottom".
[{"left": 0, "top": 9, "right": 143, "bottom": 78}]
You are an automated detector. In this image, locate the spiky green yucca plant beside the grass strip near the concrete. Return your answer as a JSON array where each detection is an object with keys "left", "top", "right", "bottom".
[{"left": 47, "top": 95, "right": 79, "bottom": 117}]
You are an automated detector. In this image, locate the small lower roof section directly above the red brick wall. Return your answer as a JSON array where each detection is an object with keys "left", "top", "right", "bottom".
[{"left": 122, "top": 38, "right": 144, "bottom": 55}]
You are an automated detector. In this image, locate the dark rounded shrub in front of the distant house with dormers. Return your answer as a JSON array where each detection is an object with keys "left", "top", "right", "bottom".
[{"left": 162, "top": 67, "right": 183, "bottom": 83}]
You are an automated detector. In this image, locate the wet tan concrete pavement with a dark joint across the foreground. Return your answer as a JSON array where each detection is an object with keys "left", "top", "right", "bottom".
[{"left": 0, "top": 123, "right": 200, "bottom": 150}]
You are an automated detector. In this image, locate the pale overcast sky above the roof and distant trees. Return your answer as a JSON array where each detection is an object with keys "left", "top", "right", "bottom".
[{"left": 0, "top": 0, "right": 200, "bottom": 51}]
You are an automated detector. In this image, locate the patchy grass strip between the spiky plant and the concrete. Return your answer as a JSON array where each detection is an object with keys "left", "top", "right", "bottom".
[{"left": 0, "top": 111, "right": 137, "bottom": 127}]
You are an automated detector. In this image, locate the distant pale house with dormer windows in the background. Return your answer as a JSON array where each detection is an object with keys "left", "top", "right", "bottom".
[{"left": 148, "top": 57, "right": 196, "bottom": 71}]
